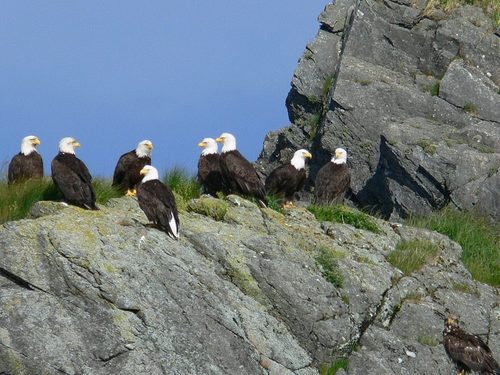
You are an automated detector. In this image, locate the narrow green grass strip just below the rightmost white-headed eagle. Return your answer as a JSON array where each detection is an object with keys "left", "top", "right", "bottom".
[{"left": 307, "top": 204, "right": 381, "bottom": 233}]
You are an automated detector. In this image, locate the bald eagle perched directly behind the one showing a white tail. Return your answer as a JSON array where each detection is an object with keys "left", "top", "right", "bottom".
[{"left": 113, "top": 140, "right": 153, "bottom": 196}]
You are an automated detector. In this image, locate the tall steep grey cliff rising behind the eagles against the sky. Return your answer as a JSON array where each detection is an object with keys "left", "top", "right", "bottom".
[{"left": 259, "top": 0, "right": 500, "bottom": 221}]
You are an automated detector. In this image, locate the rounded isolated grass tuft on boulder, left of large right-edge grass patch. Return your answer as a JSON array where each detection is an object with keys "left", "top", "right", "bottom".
[{"left": 387, "top": 239, "right": 439, "bottom": 275}]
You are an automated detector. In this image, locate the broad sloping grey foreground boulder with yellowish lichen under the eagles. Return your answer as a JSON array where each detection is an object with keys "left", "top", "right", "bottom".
[{"left": 0, "top": 196, "right": 500, "bottom": 375}]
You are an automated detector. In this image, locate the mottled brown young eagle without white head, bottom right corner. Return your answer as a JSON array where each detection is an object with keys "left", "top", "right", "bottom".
[{"left": 443, "top": 315, "right": 500, "bottom": 374}]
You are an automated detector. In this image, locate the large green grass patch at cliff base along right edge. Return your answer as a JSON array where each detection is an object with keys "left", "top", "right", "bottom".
[{"left": 409, "top": 208, "right": 500, "bottom": 287}]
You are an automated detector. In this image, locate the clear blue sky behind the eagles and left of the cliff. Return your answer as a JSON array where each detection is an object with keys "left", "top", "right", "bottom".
[{"left": 0, "top": 0, "right": 328, "bottom": 176}]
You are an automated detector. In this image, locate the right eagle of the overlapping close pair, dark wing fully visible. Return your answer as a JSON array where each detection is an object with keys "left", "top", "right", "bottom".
[{"left": 216, "top": 133, "right": 266, "bottom": 202}]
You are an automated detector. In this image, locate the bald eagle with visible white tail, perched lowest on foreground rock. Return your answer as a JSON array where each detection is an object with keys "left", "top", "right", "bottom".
[{"left": 137, "top": 165, "right": 179, "bottom": 239}]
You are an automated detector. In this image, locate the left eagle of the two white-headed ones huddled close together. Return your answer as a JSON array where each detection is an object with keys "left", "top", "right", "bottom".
[{"left": 198, "top": 138, "right": 225, "bottom": 197}]
